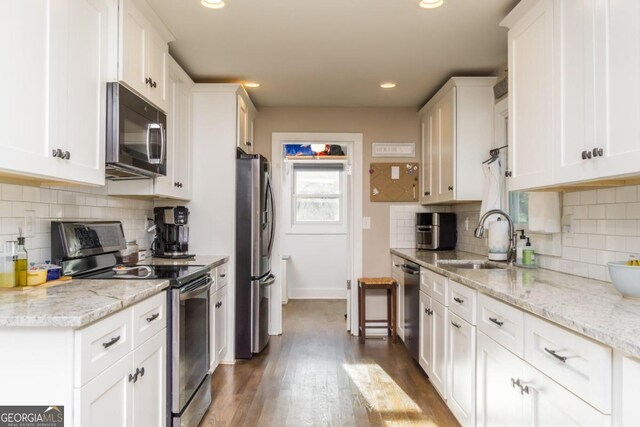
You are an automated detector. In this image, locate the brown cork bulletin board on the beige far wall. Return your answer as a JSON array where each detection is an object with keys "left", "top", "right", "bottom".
[{"left": 369, "top": 162, "right": 420, "bottom": 202}]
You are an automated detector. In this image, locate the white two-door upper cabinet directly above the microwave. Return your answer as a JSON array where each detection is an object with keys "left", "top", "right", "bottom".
[{"left": 118, "top": 0, "right": 169, "bottom": 111}]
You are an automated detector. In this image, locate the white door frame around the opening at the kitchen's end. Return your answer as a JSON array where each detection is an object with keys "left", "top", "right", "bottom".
[{"left": 269, "top": 132, "right": 363, "bottom": 335}]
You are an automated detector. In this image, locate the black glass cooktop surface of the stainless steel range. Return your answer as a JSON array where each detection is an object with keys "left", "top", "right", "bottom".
[{"left": 82, "top": 265, "right": 208, "bottom": 285}]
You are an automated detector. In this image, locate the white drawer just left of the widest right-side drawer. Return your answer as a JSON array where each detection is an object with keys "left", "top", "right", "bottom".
[{"left": 478, "top": 294, "right": 524, "bottom": 358}]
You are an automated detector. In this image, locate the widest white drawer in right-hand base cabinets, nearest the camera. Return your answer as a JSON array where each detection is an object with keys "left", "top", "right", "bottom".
[{"left": 524, "top": 314, "right": 612, "bottom": 414}]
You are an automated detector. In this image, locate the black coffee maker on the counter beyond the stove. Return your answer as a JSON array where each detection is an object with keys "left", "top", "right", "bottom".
[{"left": 153, "top": 206, "right": 193, "bottom": 258}]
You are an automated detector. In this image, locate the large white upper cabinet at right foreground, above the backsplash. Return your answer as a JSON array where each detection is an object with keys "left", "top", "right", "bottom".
[{"left": 502, "top": 0, "right": 640, "bottom": 190}]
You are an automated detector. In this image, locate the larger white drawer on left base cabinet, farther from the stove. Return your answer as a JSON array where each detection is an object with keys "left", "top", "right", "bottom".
[{"left": 75, "top": 308, "right": 133, "bottom": 387}]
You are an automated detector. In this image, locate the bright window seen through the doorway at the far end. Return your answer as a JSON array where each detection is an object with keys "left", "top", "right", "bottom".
[{"left": 292, "top": 164, "right": 343, "bottom": 225}]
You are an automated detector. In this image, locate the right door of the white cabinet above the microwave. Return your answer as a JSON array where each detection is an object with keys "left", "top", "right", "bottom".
[{"left": 145, "top": 27, "right": 169, "bottom": 111}]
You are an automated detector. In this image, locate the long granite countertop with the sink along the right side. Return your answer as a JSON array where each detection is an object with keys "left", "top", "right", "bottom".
[{"left": 391, "top": 249, "right": 640, "bottom": 357}]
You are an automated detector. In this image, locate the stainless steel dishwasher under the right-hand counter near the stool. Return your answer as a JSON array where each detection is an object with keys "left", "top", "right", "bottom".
[{"left": 399, "top": 261, "right": 420, "bottom": 362}]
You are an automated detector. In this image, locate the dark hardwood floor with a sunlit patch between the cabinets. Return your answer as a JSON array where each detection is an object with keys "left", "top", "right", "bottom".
[{"left": 200, "top": 300, "right": 458, "bottom": 427}]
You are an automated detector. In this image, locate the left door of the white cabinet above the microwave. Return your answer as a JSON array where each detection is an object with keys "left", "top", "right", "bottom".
[{"left": 120, "top": 1, "right": 149, "bottom": 96}]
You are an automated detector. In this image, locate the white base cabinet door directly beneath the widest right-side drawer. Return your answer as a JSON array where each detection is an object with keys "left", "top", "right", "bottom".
[{"left": 522, "top": 363, "right": 612, "bottom": 427}]
